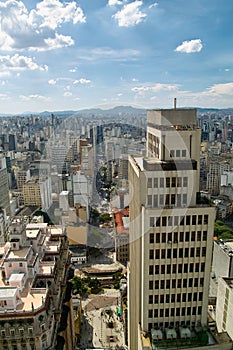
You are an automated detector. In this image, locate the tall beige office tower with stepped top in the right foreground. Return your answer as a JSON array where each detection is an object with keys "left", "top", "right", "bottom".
[{"left": 128, "top": 106, "right": 215, "bottom": 349}]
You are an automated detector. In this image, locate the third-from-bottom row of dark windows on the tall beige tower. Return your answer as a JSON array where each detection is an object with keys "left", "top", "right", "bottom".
[{"left": 149, "top": 277, "right": 204, "bottom": 290}]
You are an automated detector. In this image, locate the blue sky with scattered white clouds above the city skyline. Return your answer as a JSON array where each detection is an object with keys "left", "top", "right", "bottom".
[{"left": 0, "top": 0, "right": 233, "bottom": 113}]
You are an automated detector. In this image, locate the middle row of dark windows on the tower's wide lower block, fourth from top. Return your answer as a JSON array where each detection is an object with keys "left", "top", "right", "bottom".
[{"left": 149, "top": 262, "right": 205, "bottom": 281}]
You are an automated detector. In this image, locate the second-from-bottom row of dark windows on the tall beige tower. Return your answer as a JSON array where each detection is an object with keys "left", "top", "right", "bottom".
[{"left": 148, "top": 292, "right": 203, "bottom": 304}]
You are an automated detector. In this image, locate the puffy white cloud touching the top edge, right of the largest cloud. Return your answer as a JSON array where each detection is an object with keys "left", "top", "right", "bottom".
[{"left": 112, "top": 0, "right": 147, "bottom": 27}]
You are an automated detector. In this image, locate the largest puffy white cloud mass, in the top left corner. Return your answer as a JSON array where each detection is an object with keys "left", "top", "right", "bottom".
[{"left": 0, "top": 0, "right": 86, "bottom": 51}]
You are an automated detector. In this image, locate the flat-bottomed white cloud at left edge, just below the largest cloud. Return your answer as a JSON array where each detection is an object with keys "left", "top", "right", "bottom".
[{"left": 0, "top": 54, "right": 48, "bottom": 71}]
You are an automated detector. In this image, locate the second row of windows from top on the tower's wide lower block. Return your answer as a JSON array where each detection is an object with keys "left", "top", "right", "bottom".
[{"left": 149, "top": 231, "right": 207, "bottom": 244}]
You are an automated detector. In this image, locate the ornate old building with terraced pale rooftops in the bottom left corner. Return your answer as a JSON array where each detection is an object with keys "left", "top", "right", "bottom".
[{"left": 0, "top": 218, "right": 74, "bottom": 350}]
